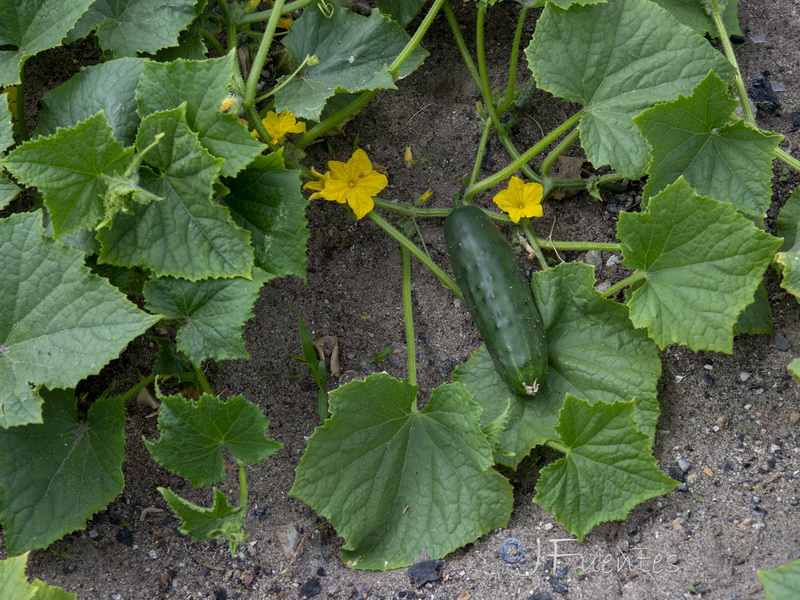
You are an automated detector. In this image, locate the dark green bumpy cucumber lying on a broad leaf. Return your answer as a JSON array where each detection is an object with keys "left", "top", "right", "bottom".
[{"left": 444, "top": 206, "right": 547, "bottom": 396}]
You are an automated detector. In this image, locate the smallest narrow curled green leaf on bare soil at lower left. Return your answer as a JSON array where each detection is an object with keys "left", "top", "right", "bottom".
[{"left": 158, "top": 487, "right": 245, "bottom": 542}]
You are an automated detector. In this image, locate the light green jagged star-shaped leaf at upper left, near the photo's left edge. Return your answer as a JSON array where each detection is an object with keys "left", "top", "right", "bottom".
[{"left": 2, "top": 111, "right": 133, "bottom": 238}]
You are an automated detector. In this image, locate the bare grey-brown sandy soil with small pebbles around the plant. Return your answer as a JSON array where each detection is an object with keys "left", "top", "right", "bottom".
[{"left": 0, "top": 0, "right": 800, "bottom": 600}]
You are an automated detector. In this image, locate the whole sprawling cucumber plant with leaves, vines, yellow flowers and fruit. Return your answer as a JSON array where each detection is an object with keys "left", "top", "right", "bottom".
[{"left": 0, "top": 0, "right": 800, "bottom": 592}]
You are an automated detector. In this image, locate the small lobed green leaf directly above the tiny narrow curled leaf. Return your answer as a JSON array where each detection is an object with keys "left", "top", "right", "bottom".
[{"left": 144, "top": 394, "right": 283, "bottom": 487}]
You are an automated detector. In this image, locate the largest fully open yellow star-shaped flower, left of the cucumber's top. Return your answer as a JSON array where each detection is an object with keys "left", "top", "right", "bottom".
[{"left": 322, "top": 148, "right": 389, "bottom": 219}]
